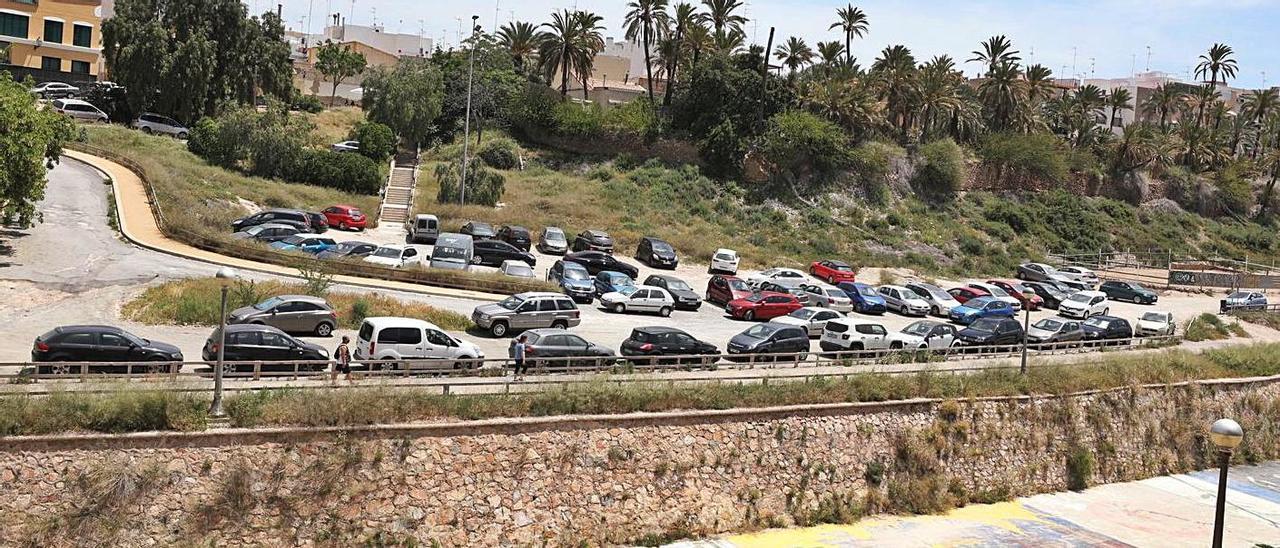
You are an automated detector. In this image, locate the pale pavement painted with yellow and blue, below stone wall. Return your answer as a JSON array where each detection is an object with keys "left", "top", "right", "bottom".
[{"left": 668, "top": 462, "right": 1280, "bottom": 548}]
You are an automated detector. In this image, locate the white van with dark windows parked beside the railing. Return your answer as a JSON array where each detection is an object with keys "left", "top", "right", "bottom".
[{"left": 352, "top": 316, "right": 484, "bottom": 369}]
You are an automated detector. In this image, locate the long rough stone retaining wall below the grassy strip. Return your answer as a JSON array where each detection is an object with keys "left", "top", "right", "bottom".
[{"left": 0, "top": 378, "right": 1280, "bottom": 547}]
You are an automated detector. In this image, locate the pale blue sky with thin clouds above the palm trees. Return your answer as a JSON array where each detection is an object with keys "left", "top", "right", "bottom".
[{"left": 252, "top": 0, "right": 1280, "bottom": 88}]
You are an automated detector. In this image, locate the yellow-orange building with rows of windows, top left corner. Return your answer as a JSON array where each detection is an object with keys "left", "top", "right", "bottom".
[{"left": 0, "top": 0, "right": 102, "bottom": 78}]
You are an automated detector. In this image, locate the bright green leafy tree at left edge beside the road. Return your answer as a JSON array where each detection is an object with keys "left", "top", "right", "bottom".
[{"left": 0, "top": 72, "right": 76, "bottom": 227}]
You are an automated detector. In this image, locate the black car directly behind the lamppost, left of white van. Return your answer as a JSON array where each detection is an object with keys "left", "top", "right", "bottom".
[{"left": 200, "top": 324, "right": 329, "bottom": 373}]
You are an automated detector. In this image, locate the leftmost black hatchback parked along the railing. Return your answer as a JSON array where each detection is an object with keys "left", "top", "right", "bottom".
[{"left": 31, "top": 325, "right": 182, "bottom": 374}]
